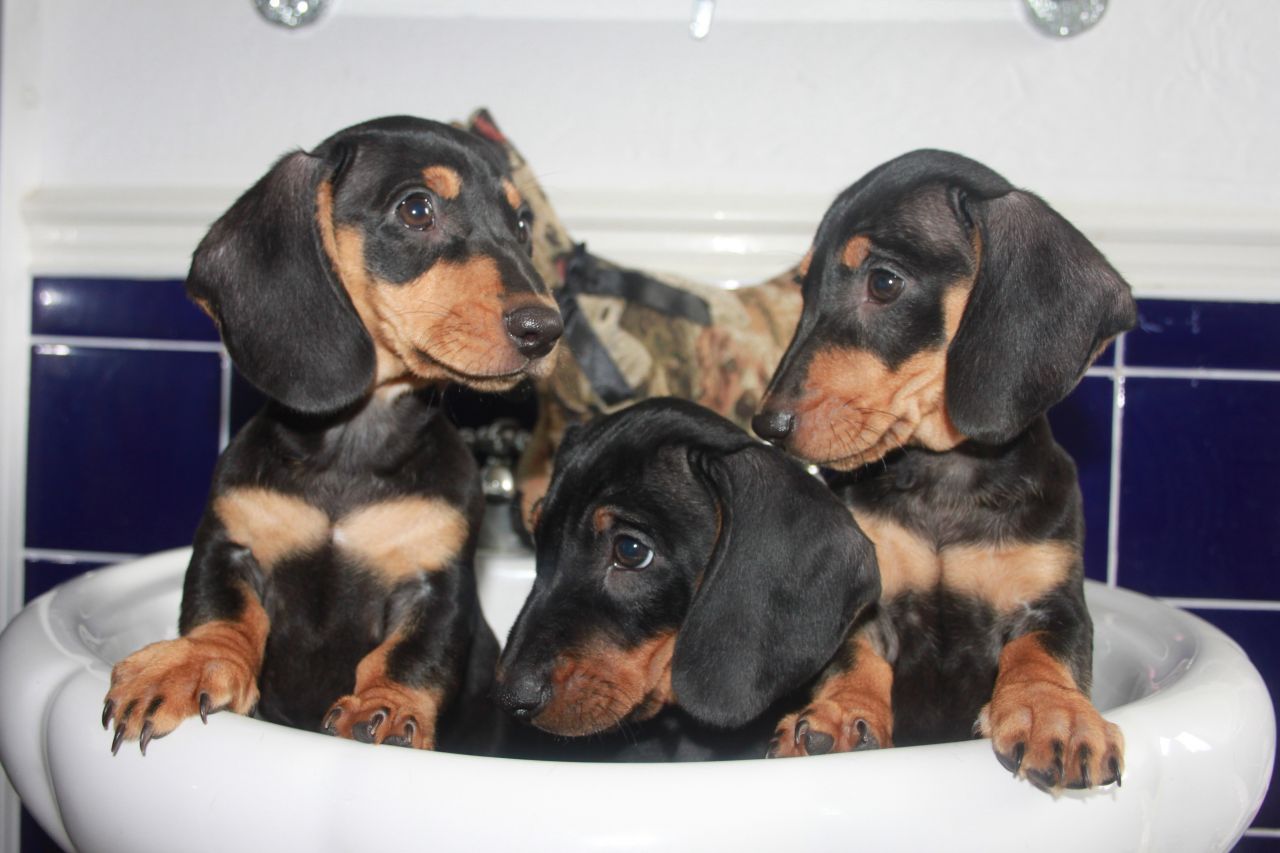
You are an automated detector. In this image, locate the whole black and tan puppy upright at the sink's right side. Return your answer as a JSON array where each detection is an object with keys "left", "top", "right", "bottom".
[{"left": 753, "top": 151, "right": 1135, "bottom": 789}]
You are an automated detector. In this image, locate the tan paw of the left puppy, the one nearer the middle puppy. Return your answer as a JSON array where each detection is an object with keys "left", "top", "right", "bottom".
[{"left": 321, "top": 680, "right": 436, "bottom": 749}]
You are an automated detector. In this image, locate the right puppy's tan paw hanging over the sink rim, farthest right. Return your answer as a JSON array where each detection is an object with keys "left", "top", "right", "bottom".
[{"left": 975, "top": 681, "right": 1124, "bottom": 793}]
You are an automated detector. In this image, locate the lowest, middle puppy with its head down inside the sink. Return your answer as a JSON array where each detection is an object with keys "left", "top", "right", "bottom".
[{"left": 497, "top": 398, "right": 879, "bottom": 756}]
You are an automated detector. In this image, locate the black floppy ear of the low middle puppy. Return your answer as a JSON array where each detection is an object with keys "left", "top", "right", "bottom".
[{"left": 672, "top": 444, "right": 879, "bottom": 726}]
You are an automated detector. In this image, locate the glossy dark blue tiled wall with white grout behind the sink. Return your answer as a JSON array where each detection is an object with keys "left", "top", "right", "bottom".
[{"left": 12, "top": 278, "right": 1280, "bottom": 853}]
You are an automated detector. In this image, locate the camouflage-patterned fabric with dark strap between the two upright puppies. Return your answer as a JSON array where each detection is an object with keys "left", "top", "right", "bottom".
[{"left": 466, "top": 110, "right": 801, "bottom": 520}]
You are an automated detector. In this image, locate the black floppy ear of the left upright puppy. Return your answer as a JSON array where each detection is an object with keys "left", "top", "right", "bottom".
[{"left": 187, "top": 145, "right": 375, "bottom": 414}]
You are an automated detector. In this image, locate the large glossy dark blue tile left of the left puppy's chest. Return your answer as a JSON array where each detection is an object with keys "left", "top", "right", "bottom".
[{"left": 27, "top": 345, "right": 221, "bottom": 553}]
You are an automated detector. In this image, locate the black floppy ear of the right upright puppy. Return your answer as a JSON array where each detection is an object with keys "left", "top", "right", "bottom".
[{"left": 946, "top": 191, "right": 1137, "bottom": 444}]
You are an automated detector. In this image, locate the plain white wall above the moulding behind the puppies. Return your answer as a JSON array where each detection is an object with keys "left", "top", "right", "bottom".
[{"left": 17, "top": 0, "right": 1280, "bottom": 207}]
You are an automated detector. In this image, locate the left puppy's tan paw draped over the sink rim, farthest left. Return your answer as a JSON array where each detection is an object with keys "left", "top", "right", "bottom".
[{"left": 102, "top": 626, "right": 260, "bottom": 754}]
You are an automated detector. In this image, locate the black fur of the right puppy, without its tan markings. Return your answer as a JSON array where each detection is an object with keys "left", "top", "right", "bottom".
[{"left": 753, "top": 151, "right": 1135, "bottom": 773}]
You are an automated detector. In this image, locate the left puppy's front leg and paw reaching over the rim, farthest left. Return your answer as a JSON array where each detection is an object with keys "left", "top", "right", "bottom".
[{"left": 102, "top": 529, "right": 270, "bottom": 754}]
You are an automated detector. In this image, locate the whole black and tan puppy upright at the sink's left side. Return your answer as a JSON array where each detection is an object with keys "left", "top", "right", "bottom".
[{"left": 102, "top": 117, "right": 561, "bottom": 751}]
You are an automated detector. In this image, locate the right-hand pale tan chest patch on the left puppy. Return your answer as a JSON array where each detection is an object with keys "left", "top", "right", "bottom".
[{"left": 333, "top": 497, "right": 470, "bottom": 583}]
